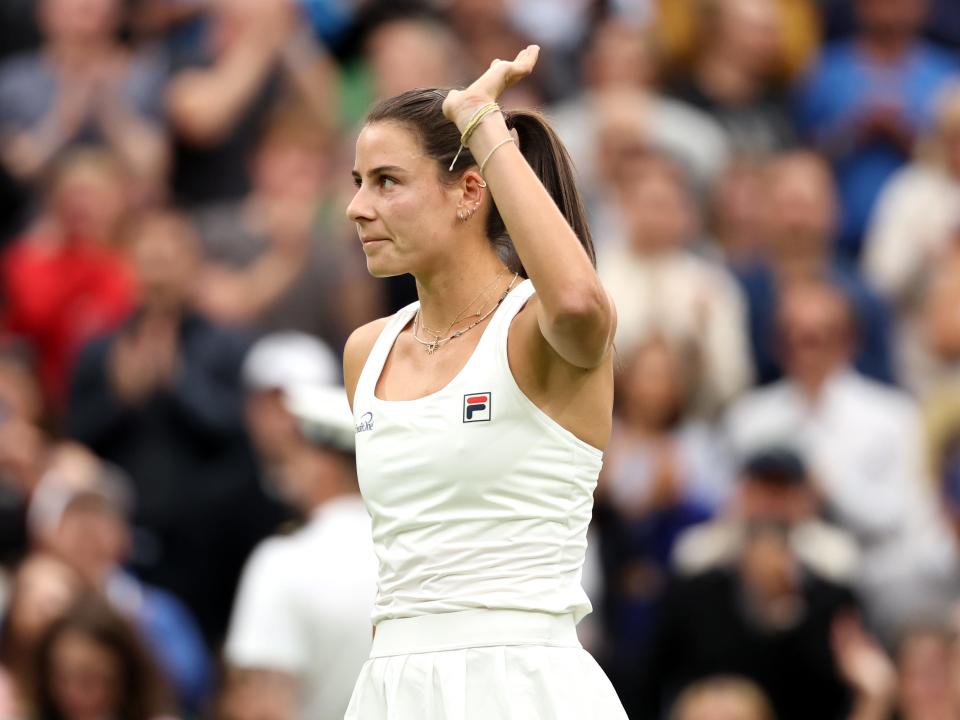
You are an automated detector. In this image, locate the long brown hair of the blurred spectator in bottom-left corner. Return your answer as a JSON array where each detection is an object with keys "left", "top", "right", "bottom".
[{"left": 31, "top": 594, "right": 172, "bottom": 720}]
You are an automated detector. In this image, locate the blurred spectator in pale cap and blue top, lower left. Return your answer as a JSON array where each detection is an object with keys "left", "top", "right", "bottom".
[{"left": 33, "top": 458, "right": 212, "bottom": 713}]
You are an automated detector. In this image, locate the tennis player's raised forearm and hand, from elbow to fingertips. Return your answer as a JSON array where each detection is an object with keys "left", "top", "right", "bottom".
[{"left": 443, "top": 45, "right": 616, "bottom": 368}]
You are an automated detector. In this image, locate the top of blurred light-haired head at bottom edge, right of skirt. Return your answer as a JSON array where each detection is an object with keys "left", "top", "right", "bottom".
[{"left": 670, "top": 677, "right": 774, "bottom": 720}]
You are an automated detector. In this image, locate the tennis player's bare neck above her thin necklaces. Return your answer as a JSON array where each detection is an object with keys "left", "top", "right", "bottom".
[{"left": 415, "top": 241, "right": 513, "bottom": 330}]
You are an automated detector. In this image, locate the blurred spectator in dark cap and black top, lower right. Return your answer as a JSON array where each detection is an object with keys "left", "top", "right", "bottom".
[{"left": 631, "top": 450, "right": 855, "bottom": 720}]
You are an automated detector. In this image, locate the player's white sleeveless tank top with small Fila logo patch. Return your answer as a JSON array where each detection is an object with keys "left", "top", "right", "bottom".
[{"left": 353, "top": 280, "right": 603, "bottom": 624}]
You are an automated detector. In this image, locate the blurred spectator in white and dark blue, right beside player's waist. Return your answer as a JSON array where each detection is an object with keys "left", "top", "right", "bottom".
[{"left": 597, "top": 337, "right": 732, "bottom": 696}]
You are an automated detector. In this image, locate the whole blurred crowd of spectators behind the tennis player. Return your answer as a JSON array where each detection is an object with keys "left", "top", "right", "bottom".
[{"left": 0, "top": 0, "right": 960, "bottom": 720}]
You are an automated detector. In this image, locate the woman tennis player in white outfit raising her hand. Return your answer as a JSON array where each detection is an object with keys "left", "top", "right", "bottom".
[{"left": 344, "top": 46, "right": 626, "bottom": 720}]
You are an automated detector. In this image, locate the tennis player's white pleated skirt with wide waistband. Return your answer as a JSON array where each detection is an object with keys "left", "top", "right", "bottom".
[{"left": 345, "top": 610, "right": 627, "bottom": 720}]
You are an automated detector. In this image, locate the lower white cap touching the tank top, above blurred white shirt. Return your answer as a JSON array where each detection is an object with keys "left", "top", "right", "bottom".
[{"left": 284, "top": 385, "right": 356, "bottom": 452}]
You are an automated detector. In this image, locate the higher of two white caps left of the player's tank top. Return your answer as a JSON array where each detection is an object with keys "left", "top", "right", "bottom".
[{"left": 243, "top": 332, "right": 340, "bottom": 390}]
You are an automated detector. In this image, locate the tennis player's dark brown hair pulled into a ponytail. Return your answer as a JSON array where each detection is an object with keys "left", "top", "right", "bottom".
[{"left": 367, "top": 89, "right": 596, "bottom": 277}]
